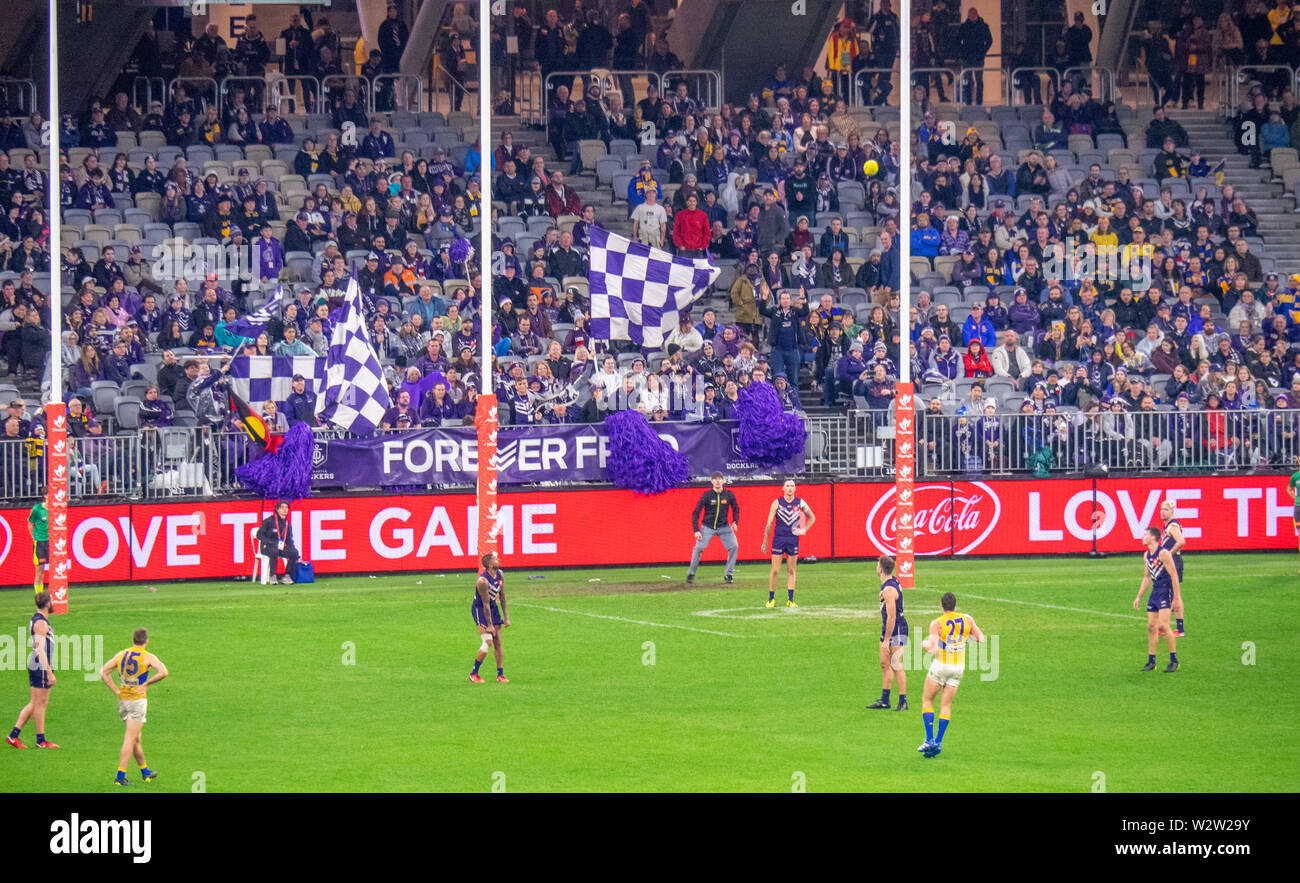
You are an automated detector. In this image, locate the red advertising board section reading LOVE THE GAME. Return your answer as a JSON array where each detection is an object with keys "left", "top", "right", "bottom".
[{"left": 0, "top": 484, "right": 832, "bottom": 584}]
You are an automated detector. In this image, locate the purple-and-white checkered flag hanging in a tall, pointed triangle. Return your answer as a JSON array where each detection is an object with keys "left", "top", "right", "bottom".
[{"left": 316, "top": 280, "right": 393, "bottom": 436}]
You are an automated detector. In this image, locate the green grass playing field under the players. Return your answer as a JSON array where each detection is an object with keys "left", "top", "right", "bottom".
[{"left": 0, "top": 554, "right": 1300, "bottom": 792}]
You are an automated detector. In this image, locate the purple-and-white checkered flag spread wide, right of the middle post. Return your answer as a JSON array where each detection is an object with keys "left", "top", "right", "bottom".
[{"left": 588, "top": 226, "right": 719, "bottom": 347}]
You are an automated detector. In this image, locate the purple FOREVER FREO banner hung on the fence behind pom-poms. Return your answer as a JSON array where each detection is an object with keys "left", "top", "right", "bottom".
[{"left": 312, "top": 421, "right": 803, "bottom": 488}]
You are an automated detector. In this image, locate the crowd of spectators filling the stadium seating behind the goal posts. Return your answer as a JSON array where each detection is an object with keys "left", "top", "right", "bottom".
[{"left": 0, "top": 3, "right": 1300, "bottom": 486}]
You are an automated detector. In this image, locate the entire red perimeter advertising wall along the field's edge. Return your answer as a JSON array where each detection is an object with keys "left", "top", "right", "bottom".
[{"left": 0, "top": 475, "right": 1295, "bottom": 585}]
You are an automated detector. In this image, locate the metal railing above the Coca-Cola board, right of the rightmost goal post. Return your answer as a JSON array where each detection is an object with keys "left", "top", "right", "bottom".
[{"left": 917, "top": 408, "right": 1300, "bottom": 477}]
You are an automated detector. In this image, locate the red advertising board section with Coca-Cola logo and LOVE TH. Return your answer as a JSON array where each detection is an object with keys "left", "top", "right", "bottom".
[{"left": 835, "top": 476, "right": 1295, "bottom": 558}]
